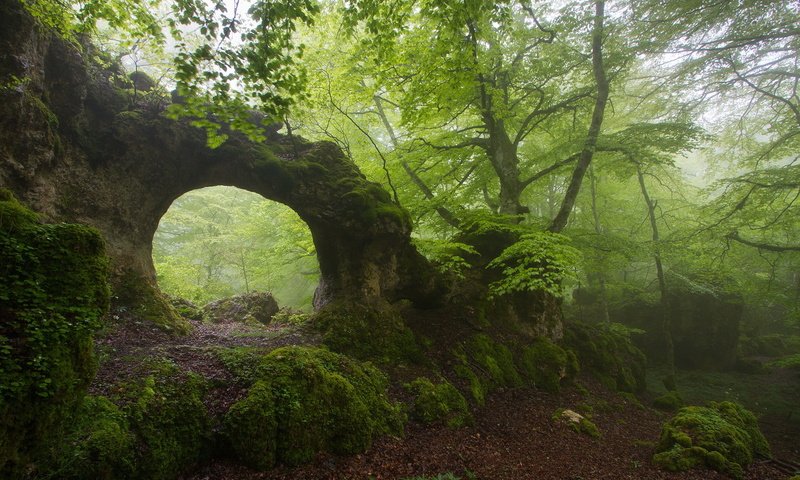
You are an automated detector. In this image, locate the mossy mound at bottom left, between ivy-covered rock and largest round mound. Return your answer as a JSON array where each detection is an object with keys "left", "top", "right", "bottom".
[{"left": 42, "top": 359, "right": 212, "bottom": 480}]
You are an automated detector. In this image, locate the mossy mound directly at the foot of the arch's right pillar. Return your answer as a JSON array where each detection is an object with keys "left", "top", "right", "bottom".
[{"left": 312, "top": 301, "right": 422, "bottom": 365}]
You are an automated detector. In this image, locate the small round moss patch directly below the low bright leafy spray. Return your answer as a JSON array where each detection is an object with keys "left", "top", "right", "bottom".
[{"left": 521, "top": 337, "right": 577, "bottom": 392}]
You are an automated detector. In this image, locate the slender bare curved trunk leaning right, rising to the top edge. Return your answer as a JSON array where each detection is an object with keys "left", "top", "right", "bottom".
[{"left": 549, "top": 0, "right": 609, "bottom": 232}]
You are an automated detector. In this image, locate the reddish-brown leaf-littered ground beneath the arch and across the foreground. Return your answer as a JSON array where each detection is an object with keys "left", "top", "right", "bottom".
[{"left": 90, "top": 312, "right": 800, "bottom": 480}]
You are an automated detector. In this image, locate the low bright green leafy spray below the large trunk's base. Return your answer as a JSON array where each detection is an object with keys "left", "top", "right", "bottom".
[{"left": 488, "top": 232, "right": 580, "bottom": 297}]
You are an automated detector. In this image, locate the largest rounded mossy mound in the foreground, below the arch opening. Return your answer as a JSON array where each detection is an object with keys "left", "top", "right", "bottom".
[{"left": 224, "top": 347, "right": 404, "bottom": 470}]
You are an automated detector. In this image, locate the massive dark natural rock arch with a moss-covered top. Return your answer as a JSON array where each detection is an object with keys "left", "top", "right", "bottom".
[{"left": 0, "top": 0, "right": 432, "bottom": 322}]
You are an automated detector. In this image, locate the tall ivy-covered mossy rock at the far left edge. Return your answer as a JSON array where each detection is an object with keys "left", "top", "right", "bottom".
[{"left": 0, "top": 190, "right": 109, "bottom": 478}]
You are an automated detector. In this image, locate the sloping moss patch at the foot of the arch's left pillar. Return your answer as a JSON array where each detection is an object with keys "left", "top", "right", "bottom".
[{"left": 114, "top": 270, "right": 191, "bottom": 335}]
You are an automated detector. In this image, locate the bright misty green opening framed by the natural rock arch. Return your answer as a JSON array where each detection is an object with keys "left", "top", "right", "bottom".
[{"left": 152, "top": 186, "right": 320, "bottom": 311}]
